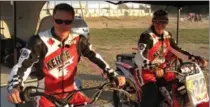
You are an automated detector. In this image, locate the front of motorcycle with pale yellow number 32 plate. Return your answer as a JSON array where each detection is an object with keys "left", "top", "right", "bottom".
[{"left": 176, "top": 62, "right": 209, "bottom": 107}]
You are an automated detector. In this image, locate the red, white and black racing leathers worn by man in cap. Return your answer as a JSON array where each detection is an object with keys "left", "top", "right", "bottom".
[{"left": 135, "top": 26, "right": 203, "bottom": 85}]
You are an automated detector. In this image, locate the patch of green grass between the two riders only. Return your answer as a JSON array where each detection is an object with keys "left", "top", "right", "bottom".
[{"left": 90, "top": 28, "right": 144, "bottom": 46}]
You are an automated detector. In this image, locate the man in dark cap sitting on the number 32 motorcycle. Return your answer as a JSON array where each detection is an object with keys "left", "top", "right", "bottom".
[{"left": 135, "top": 10, "right": 207, "bottom": 107}]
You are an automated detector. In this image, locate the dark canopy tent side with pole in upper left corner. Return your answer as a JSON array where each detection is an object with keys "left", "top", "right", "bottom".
[{"left": 0, "top": 1, "right": 46, "bottom": 62}]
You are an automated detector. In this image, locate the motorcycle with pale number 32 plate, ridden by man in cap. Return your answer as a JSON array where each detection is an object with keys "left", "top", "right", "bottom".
[{"left": 113, "top": 49, "right": 209, "bottom": 107}]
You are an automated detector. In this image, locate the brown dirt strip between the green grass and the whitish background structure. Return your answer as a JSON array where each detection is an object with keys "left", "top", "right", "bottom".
[{"left": 86, "top": 16, "right": 209, "bottom": 29}]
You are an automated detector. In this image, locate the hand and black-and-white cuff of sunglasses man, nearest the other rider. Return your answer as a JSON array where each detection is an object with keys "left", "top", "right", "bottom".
[{"left": 107, "top": 69, "right": 125, "bottom": 87}]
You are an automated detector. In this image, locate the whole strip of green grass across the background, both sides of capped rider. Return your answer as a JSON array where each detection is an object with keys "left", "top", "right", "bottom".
[{"left": 90, "top": 28, "right": 209, "bottom": 46}]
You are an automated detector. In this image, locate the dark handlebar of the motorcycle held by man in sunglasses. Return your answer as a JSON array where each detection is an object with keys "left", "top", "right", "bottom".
[{"left": 20, "top": 82, "right": 130, "bottom": 107}]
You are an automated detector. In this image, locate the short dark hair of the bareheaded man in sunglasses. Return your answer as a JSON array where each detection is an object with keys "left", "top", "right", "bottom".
[{"left": 53, "top": 3, "right": 75, "bottom": 18}]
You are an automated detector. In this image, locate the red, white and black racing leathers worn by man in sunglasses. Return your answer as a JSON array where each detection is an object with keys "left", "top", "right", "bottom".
[{"left": 8, "top": 28, "right": 116, "bottom": 107}]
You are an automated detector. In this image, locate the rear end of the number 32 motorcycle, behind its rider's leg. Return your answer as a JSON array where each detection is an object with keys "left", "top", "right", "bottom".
[{"left": 113, "top": 49, "right": 141, "bottom": 107}]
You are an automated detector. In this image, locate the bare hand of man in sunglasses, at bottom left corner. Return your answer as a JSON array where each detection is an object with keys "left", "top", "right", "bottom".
[{"left": 7, "top": 88, "right": 22, "bottom": 104}]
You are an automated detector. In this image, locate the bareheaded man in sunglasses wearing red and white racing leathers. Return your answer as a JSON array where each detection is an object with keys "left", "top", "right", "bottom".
[{"left": 8, "top": 3, "right": 125, "bottom": 107}]
